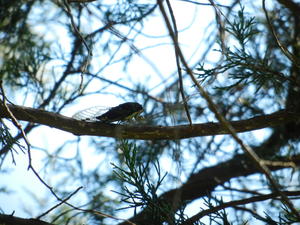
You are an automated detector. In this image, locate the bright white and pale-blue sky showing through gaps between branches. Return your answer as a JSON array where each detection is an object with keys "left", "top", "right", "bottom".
[{"left": 0, "top": 1, "right": 272, "bottom": 223}]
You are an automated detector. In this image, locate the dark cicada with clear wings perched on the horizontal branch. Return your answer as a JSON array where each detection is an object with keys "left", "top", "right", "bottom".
[{"left": 72, "top": 102, "right": 143, "bottom": 123}]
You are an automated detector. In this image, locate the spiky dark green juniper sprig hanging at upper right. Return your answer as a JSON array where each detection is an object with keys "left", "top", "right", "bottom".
[{"left": 197, "top": 8, "right": 288, "bottom": 93}]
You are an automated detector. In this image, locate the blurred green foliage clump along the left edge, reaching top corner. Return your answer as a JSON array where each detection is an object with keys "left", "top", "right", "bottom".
[{"left": 0, "top": 1, "right": 50, "bottom": 88}]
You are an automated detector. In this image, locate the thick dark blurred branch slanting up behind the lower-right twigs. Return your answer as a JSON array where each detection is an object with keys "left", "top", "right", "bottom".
[{"left": 120, "top": 154, "right": 300, "bottom": 225}]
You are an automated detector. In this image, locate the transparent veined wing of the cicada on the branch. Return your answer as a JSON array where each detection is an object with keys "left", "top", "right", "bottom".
[{"left": 72, "top": 106, "right": 110, "bottom": 122}]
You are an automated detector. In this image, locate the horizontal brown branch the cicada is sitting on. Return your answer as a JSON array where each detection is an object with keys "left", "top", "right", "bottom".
[{"left": 0, "top": 104, "right": 300, "bottom": 140}]
